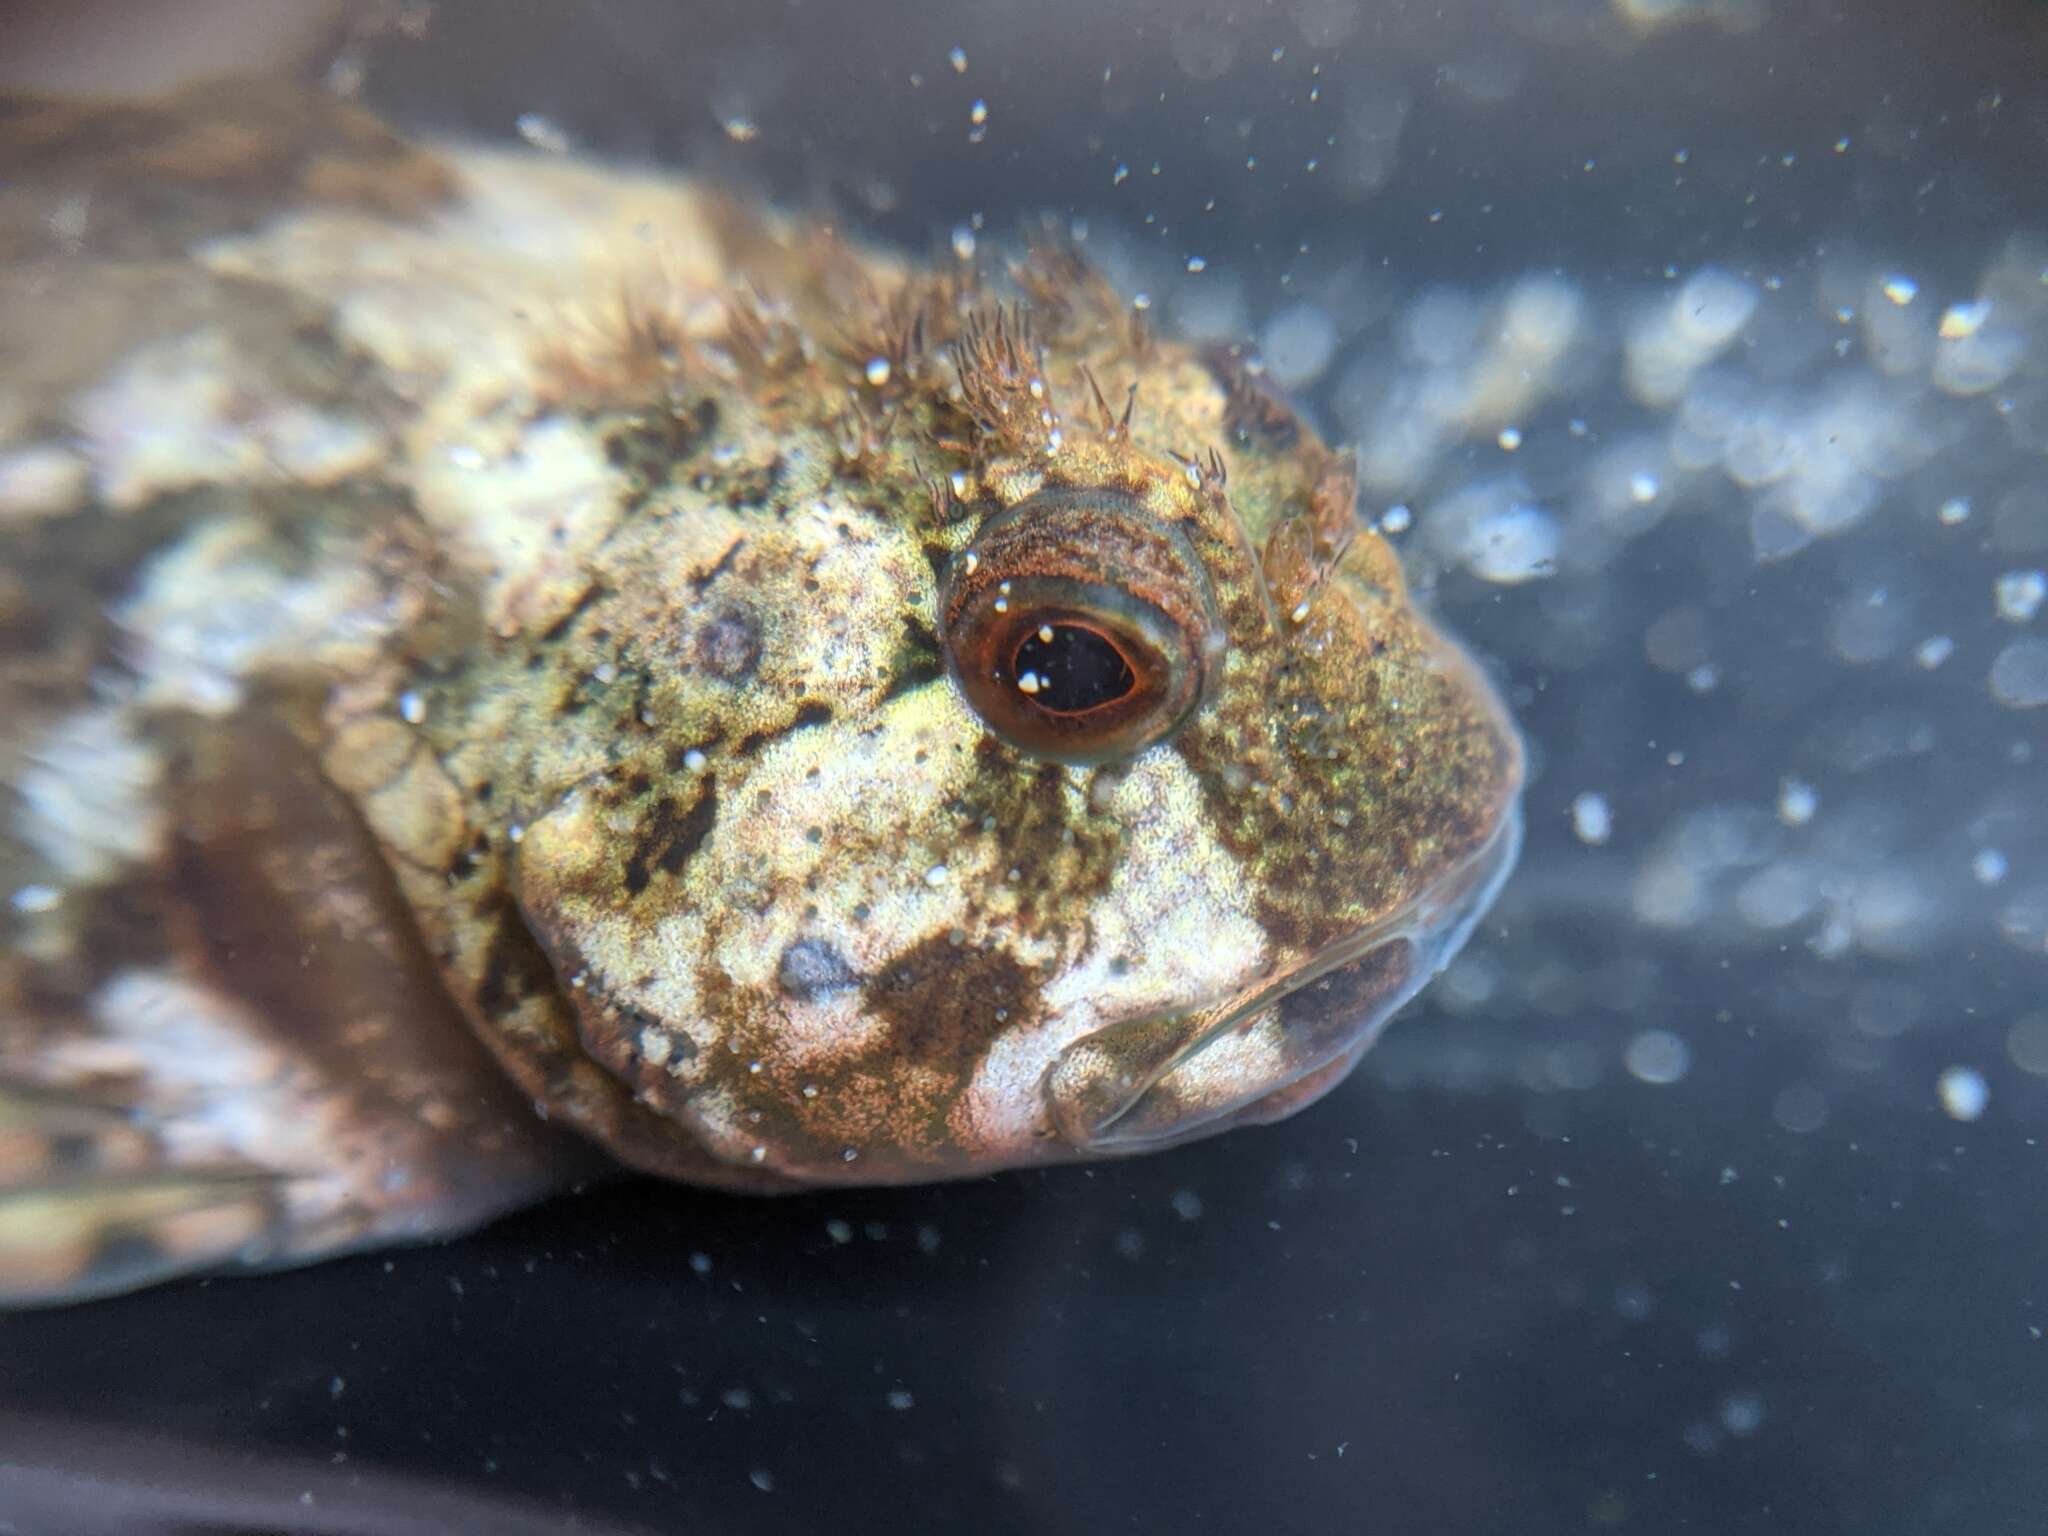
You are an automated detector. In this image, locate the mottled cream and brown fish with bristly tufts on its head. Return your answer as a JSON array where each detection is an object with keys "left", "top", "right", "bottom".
[{"left": 0, "top": 90, "right": 1522, "bottom": 1300}]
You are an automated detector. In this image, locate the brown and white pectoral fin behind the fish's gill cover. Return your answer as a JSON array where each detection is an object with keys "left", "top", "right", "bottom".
[{"left": 0, "top": 723, "right": 596, "bottom": 1305}]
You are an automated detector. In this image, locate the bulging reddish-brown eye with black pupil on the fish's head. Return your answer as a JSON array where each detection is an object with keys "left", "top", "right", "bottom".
[{"left": 938, "top": 487, "right": 1223, "bottom": 764}]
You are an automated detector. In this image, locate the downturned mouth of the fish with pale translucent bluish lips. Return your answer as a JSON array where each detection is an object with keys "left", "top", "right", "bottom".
[{"left": 1042, "top": 803, "right": 1522, "bottom": 1155}]
